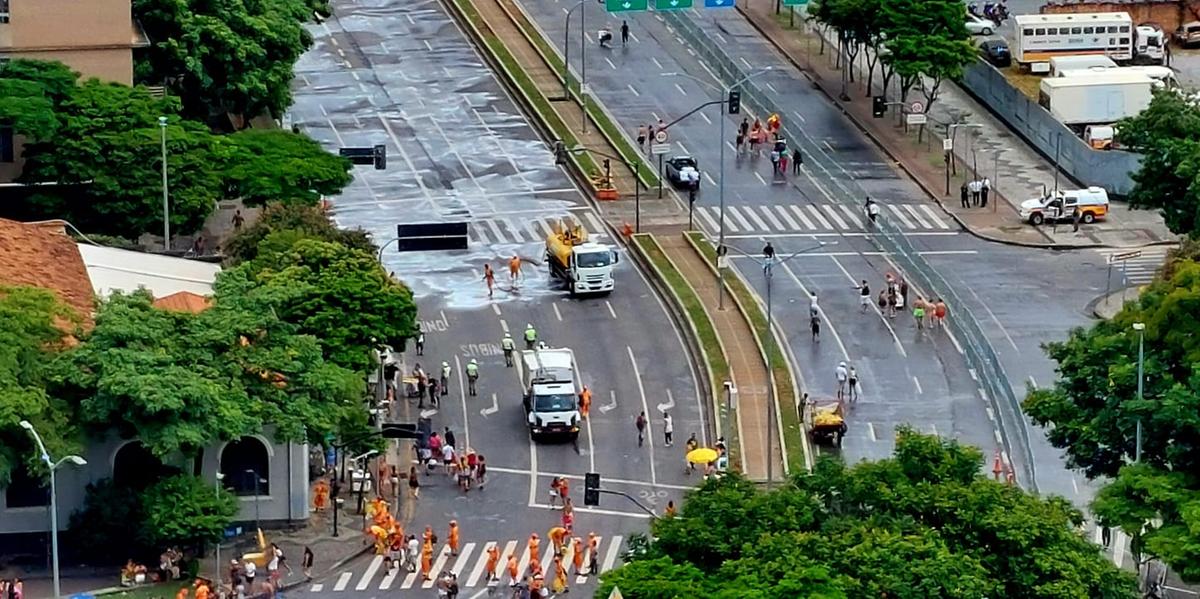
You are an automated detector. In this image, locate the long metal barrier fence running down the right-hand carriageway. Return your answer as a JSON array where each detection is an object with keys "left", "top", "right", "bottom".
[{"left": 659, "top": 11, "right": 1038, "bottom": 492}]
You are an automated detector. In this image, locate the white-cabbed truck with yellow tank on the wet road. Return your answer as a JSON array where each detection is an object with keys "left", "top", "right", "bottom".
[{"left": 546, "top": 218, "right": 617, "bottom": 296}]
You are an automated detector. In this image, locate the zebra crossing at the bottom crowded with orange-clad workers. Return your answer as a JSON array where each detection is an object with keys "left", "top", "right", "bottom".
[{"left": 308, "top": 534, "right": 624, "bottom": 593}]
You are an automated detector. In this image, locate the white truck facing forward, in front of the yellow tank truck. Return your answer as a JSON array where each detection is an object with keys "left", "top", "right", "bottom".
[{"left": 521, "top": 348, "right": 582, "bottom": 441}]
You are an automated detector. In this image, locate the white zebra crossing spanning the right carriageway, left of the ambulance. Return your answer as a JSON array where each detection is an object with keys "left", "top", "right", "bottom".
[{"left": 696, "top": 202, "right": 955, "bottom": 234}]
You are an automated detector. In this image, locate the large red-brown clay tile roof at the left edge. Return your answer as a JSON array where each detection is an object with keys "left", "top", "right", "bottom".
[{"left": 0, "top": 218, "right": 96, "bottom": 327}]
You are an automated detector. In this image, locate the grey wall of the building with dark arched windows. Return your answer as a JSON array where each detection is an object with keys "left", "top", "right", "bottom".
[{"left": 0, "top": 437, "right": 310, "bottom": 535}]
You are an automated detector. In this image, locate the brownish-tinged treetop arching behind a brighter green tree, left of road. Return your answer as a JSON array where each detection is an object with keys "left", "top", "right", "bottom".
[{"left": 224, "top": 204, "right": 379, "bottom": 265}]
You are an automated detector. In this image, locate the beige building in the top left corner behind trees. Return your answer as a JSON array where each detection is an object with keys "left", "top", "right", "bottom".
[{"left": 0, "top": 0, "right": 148, "bottom": 181}]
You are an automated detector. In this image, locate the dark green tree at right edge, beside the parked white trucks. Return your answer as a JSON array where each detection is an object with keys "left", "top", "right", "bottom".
[{"left": 1117, "top": 91, "right": 1200, "bottom": 236}]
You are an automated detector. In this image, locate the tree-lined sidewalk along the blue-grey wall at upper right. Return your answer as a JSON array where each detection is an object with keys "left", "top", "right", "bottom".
[{"left": 738, "top": 2, "right": 1176, "bottom": 248}]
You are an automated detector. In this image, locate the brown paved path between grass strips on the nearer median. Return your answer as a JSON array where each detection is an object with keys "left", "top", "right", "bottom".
[{"left": 655, "top": 230, "right": 784, "bottom": 480}]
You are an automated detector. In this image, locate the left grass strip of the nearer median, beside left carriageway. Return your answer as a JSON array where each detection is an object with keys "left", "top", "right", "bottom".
[{"left": 634, "top": 233, "right": 742, "bottom": 467}]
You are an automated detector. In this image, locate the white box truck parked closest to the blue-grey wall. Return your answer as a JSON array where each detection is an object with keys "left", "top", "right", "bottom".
[{"left": 1038, "top": 73, "right": 1154, "bottom": 128}]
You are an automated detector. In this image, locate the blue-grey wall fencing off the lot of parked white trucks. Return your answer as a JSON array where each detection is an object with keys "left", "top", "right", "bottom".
[{"left": 961, "top": 62, "right": 1141, "bottom": 194}]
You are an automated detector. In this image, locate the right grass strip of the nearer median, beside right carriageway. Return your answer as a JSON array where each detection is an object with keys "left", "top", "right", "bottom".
[{"left": 688, "top": 232, "right": 806, "bottom": 472}]
